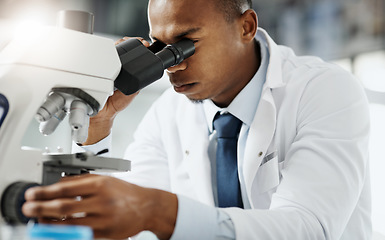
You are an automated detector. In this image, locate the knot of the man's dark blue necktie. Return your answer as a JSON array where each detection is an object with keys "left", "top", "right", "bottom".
[{"left": 213, "top": 113, "right": 242, "bottom": 138}]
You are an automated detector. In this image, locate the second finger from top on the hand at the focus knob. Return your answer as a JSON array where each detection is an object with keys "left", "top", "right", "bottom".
[{"left": 22, "top": 198, "right": 103, "bottom": 219}]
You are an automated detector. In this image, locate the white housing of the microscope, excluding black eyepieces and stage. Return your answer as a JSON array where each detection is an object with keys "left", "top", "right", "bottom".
[{"left": 0, "top": 22, "right": 121, "bottom": 223}]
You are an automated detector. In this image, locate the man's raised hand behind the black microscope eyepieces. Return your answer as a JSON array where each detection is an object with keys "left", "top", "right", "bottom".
[{"left": 83, "top": 37, "right": 150, "bottom": 145}]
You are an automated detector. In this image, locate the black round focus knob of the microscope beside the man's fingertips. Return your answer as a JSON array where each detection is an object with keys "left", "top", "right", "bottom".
[{"left": 1, "top": 182, "right": 39, "bottom": 224}]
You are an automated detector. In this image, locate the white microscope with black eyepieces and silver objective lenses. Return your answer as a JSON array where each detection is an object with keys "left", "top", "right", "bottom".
[{"left": 0, "top": 11, "right": 195, "bottom": 224}]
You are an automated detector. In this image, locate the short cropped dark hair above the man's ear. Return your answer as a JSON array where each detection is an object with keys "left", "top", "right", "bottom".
[{"left": 215, "top": 0, "right": 253, "bottom": 22}]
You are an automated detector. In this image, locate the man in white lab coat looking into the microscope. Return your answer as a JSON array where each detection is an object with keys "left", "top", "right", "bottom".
[{"left": 23, "top": 0, "right": 371, "bottom": 239}]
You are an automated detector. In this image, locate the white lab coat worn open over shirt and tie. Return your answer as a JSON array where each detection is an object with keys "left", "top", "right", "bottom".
[{"left": 121, "top": 29, "right": 371, "bottom": 240}]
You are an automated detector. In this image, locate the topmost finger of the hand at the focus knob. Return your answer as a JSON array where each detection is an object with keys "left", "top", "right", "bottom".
[{"left": 25, "top": 175, "right": 97, "bottom": 201}]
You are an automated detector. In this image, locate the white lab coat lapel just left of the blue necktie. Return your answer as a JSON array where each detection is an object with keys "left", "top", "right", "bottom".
[{"left": 177, "top": 103, "right": 214, "bottom": 206}]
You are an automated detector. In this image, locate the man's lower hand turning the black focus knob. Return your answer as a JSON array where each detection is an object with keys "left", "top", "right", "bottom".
[{"left": 22, "top": 174, "right": 178, "bottom": 239}]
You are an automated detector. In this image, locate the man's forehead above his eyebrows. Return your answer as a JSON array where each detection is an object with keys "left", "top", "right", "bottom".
[{"left": 148, "top": 0, "right": 221, "bottom": 38}]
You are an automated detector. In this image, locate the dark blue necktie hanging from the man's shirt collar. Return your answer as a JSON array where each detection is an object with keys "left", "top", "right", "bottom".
[{"left": 213, "top": 113, "right": 243, "bottom": 208}]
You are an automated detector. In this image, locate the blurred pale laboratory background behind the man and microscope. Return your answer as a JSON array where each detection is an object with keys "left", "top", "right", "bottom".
[{"left": 0, "top": 0, "right": 385, "bottom": 238}]
